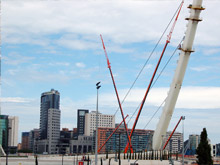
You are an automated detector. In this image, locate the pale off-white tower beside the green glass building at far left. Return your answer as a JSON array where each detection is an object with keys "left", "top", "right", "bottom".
[{"left": 8, "top": 116, "right": 18, "bottom": 147}]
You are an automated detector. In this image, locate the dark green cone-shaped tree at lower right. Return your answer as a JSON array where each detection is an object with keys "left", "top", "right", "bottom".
[{"left": 196, "top": 128, "right": 213, "bottom": 165}]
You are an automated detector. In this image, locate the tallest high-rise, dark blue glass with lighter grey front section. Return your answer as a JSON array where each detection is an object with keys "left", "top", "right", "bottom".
[{"left": 37, "top": 89, "right": 60, "bottom": 154}]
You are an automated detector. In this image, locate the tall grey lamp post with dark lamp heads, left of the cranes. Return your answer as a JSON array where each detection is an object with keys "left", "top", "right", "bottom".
[{"left": 95, "top": 82, "right": 101, "bottom": 165}]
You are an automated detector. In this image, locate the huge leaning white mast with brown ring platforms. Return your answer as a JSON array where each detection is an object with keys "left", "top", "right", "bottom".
[{"left": 153, "top": 0, "right": 204, "bottom": 150}]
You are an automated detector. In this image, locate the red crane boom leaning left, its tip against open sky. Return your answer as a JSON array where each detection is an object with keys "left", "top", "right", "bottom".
[{"left": 100, "top": 34, "right": 133, "bottom": 153}]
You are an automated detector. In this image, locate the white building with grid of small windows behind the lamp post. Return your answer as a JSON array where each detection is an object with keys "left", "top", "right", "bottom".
[{"left": 85, "top": 111, "right": 115, "bottom": 136}]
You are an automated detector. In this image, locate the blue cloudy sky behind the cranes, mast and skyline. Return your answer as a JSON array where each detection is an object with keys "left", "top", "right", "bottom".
[{"left": 1, "top": 0, "right": 220, "bottom": 144}]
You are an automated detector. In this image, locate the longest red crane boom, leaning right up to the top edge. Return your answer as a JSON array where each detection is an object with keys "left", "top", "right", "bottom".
[{"left": 124, "top": 0, "right": 184, "bottom": 153}]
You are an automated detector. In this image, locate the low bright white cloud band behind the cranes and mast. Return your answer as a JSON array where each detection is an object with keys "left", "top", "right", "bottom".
[{"left": 90, "top": 87, "right": 220, "bottom": 109}]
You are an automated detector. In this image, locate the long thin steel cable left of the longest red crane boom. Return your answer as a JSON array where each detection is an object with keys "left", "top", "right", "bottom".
[{"left": 114, "top": 1, "right": 183, "bottom": 115}]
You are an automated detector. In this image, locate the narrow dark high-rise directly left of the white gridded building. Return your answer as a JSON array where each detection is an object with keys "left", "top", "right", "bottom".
[{"left": 77, "top": 109, "right": 89, "bottom": 135}]
